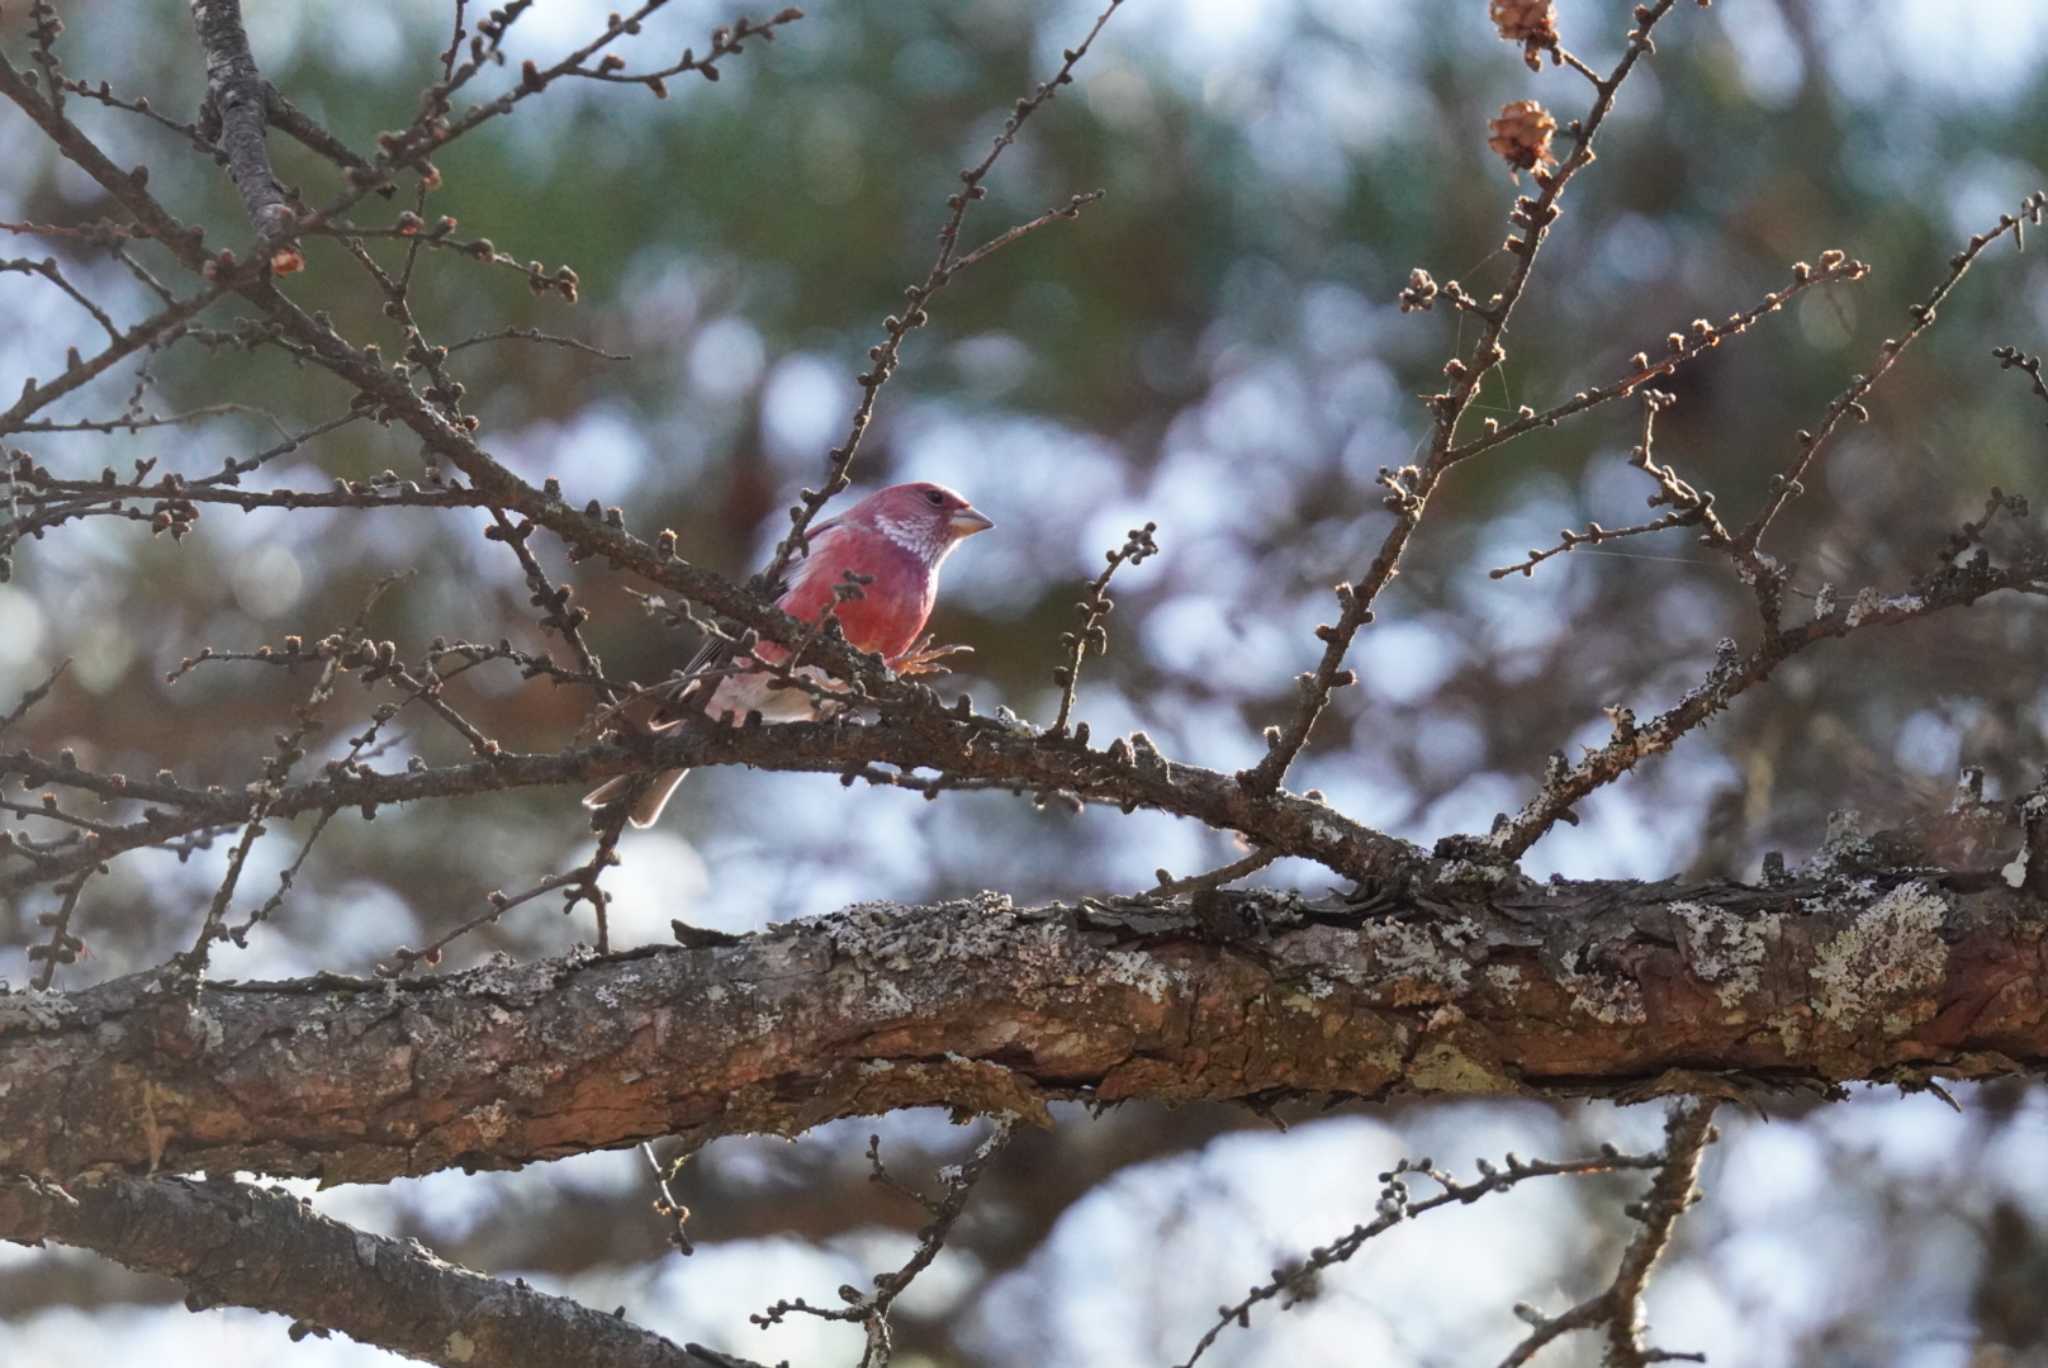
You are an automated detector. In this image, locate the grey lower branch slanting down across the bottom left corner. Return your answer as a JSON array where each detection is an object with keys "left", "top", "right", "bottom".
[{"left": 0, "top": 1178, "right": 694, "bottom": 1368}]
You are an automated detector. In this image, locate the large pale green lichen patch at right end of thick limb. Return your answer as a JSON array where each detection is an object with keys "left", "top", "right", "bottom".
[{"left": 1812, "top": 879, "right": 1948, "bottom": 1034}]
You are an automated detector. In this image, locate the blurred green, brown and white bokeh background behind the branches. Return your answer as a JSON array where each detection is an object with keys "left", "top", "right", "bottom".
[{"left": 0, "top": 0, "right": 2048, "bottom": 1368}]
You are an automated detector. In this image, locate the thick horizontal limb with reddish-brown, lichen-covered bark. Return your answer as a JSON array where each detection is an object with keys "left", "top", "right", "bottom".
[{"left": 0, "top": 870, "right": 2048, "bottom": 1182}]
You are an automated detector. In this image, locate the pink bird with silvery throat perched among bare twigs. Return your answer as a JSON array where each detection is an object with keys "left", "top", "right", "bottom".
[{"left": 584, "top": 483, "right": 995, "bottom": 827}]
